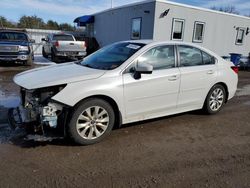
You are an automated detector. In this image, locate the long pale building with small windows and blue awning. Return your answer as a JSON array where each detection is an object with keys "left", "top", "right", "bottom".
[{"left": 74, "top": 0, "right": 250, "bottom": 56}]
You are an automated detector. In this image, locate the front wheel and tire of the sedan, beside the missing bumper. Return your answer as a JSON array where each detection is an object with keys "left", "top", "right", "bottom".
[{"left": 67, "top": 98, "right": 115, "bottom": 145}]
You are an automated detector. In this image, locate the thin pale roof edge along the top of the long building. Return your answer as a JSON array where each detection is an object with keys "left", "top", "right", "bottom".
[{"left": 93, "top": 0, "right": 250, "bottom": 20}]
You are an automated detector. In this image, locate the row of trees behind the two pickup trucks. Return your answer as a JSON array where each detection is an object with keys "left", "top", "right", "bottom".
[{"left": 0, "top": 16, "right": 75, "bottom": 31}]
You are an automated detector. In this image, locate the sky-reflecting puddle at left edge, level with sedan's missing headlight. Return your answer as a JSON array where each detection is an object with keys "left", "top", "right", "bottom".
[{"left": 0, "top": 90, "right": 21, "bottom": 108}]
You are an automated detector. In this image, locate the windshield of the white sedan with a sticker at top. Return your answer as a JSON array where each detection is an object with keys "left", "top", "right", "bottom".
[{"left": 80, "top": 42, "right": 145, "bottom": 70}]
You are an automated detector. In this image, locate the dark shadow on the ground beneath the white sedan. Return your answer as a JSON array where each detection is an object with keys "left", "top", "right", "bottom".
[{"left": 10, "top": 110, "right": 206, "bottom": 148}]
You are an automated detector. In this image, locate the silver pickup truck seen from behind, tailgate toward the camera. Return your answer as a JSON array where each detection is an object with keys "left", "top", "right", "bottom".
[{"left": 42, "top": 33, "right": 86, "bottom": 63}]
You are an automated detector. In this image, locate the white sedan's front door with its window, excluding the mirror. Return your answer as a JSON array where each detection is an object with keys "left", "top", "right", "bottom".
[{"left": 123, "top": 45, "right": 180, "bottom": 121}]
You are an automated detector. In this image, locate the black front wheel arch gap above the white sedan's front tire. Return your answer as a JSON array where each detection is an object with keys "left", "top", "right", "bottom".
[{"left": 74, "top": 95, "right": 122, "bottom": 128}]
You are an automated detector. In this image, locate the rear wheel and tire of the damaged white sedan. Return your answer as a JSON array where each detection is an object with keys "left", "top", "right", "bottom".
[{"left": 203, "top": 84, "right": 226, "bottom": 114}]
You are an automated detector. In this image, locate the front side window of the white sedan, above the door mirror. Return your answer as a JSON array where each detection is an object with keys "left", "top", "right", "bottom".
[{"left": 138, "top": 45, "right": 175, "bottom": 70}]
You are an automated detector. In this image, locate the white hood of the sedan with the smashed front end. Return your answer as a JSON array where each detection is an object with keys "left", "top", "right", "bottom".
[{"left": 14, "top": 63, "right": 105, "bottom": 89}]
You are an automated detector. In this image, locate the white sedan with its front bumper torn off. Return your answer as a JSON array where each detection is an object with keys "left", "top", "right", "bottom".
[{"left": 10, "top": 40, "right": 238, "bottom": 145}]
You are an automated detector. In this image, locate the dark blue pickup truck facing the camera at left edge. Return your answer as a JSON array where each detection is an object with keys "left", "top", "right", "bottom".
[{"left": 0, "top": 29, "right": 34, "bottom": 65}]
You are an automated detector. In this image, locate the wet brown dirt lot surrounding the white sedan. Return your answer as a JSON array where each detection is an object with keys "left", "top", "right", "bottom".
[{"left": 0, "top": 57, "right": 250, "bottom": 188}]
